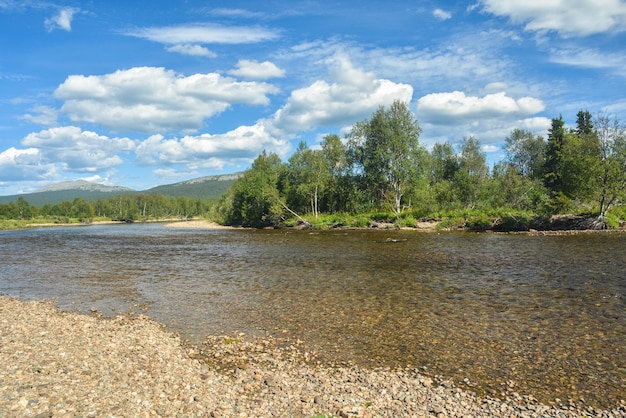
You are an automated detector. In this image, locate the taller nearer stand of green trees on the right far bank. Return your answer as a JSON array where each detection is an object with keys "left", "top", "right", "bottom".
[{"left": 216, "top": 101, "right": 626, "bottom": 227}]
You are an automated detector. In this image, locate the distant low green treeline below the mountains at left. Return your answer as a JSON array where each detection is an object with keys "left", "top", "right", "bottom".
[{"left": 0, "top": 194, "right": 211, "bottom": 222}]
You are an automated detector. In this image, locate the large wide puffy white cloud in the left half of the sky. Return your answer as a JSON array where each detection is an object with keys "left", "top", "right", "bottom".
[{"left": 55, "top": 67, "right": 278, "bottom": 133}]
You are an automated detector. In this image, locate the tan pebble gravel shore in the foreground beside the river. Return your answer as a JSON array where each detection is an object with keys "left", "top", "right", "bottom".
[{"left": 0, "top": 296, "right": 626, "bottom": 417}]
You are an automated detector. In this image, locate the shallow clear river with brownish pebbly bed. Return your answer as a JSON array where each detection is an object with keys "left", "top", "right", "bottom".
[{"left": 0, "top": 224, "right": 626, "bottom": 407}]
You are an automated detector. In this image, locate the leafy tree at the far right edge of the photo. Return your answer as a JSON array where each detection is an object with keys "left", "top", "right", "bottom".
[{"left": 594, "top": 114, "right": 626, "bottom": 221}]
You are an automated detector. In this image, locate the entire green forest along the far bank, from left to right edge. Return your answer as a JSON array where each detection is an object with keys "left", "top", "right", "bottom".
[{"left": 0, "top": 101, "right": 626, "bottom": 230}]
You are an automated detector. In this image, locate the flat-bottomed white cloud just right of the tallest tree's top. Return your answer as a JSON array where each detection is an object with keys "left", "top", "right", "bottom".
[{"left": 417, "top": 91, "right": 545, "bottom": 124}]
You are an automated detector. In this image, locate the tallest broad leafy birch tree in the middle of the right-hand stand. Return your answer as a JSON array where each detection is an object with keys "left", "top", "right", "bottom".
[{"left": 350, "top": 100, "right": 422, "bottom": 216}]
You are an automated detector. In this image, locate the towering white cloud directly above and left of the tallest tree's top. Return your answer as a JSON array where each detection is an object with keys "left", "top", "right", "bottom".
[{"left": 272, "top": 56, "right": 413, "bottom": 132}]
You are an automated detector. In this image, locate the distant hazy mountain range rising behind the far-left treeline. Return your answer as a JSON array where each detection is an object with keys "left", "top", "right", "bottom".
[{"left": 0, "top": 173, "right": 243, "bottom": 207}]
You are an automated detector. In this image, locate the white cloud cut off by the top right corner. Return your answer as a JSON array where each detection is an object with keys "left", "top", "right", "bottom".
[{"left": 480, "top": 0, "right": 626, "bottom": 37}]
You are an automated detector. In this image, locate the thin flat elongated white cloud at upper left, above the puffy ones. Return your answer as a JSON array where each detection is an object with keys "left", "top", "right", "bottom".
[{"left": 124, "top": 24, "right": 278, "bottom": 45}]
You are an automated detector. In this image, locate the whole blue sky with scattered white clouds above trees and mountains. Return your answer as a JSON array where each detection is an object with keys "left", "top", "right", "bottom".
[{"left": 0, "top": 0, "right": 626, "bottom": 195}]
